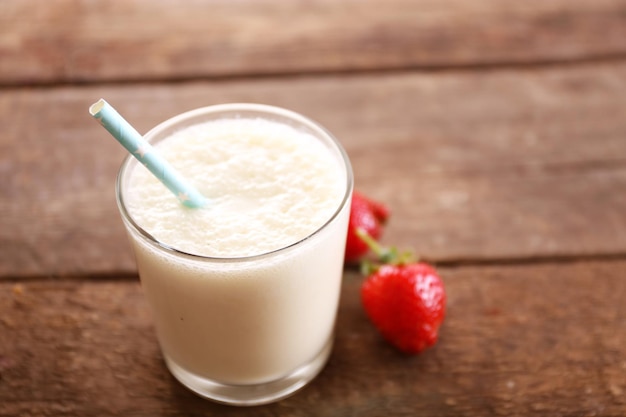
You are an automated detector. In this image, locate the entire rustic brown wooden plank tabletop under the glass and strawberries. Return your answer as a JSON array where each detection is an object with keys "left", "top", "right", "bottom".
[{"left": 0, "top": 0, "right": 626, "bottom": 416}]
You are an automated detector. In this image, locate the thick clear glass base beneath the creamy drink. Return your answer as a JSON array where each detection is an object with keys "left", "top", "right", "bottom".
[{"left": 165, "top": 337, "right": 333, "bottom": 406}]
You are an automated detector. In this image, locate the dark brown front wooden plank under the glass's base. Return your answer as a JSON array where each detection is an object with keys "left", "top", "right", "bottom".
[{"left": 0, "top": 260, "right": 626, "bottom": 417}]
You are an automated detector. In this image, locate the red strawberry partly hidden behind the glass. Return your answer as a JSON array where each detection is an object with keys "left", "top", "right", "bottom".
[{"left": 345, "top": 191, "right": 389, "bottom": 263}]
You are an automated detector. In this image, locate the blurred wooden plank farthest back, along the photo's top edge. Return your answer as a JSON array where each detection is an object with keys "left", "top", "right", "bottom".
[{"left": 0, "top": 0, "right": 626, "bottom": 85}]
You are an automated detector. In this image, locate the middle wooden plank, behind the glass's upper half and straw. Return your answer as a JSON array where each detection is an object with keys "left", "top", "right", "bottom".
[{"left": 0, "top": 64, "right": 626, "bottom": 277}]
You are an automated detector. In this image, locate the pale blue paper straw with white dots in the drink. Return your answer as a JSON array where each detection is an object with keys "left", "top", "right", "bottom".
[{"left": 89, "top": 99, "right": 206, "bottom": 208}]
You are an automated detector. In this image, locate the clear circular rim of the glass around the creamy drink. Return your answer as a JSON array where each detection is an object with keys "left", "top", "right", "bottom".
[{"left": 115, "top": 103, "right": 354, "bottom": 263}]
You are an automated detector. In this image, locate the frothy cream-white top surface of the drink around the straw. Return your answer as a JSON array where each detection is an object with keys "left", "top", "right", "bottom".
[{"left": 126, "top": 119, "right": 345, "bottom": 257}]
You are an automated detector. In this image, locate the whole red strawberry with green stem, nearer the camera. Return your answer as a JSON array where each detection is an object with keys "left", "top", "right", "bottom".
[{"left": 361, "top": 229, "right": 446, "bottom": 354}]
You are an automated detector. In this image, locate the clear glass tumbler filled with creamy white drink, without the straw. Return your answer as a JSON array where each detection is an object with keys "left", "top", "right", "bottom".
[{"left": 117, "top": 104, "right": 353, "bottom": 405}]
